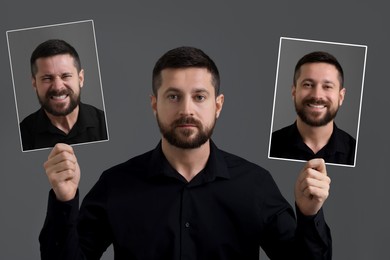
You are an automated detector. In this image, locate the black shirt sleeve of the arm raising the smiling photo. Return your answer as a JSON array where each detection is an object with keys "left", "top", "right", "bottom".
[{"left": 260, "top": 172, "right": 332, "bottom": 260}]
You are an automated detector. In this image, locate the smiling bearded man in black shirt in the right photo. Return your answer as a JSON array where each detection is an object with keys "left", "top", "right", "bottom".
[{"left": 270, "top": 51, "right": 356, "bottom": 165}]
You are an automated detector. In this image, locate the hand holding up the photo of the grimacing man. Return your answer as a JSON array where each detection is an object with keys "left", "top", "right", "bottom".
[{"left": 43, "top": 144, "right": 80, "bottom": 201}]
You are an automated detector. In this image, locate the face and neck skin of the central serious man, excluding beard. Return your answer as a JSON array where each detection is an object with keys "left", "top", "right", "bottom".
[{"left": 151, "top": 68, "right": 224, "bottom": 181}]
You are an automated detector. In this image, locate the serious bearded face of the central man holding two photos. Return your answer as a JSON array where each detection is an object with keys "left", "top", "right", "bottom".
[{"left": 152, "top": 68, "right": 224, "bottom": 149}]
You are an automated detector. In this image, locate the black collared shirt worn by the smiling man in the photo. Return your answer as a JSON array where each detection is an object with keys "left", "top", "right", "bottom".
[{"left": 270, "top": 122, "right": 356, "bottom": 165}]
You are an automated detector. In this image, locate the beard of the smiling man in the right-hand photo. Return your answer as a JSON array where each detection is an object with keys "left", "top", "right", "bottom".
[{"left": 294, "top": 98, "right": 339, "bottom": 127}]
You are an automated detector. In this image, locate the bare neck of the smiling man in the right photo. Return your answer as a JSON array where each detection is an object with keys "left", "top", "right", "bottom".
[{"left": 297, "top": 117, "right": 333, "bottom": 153}]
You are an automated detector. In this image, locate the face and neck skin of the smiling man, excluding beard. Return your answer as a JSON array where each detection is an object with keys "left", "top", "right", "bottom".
[{"left": 292, "top": 62, "right": 346, "bottom": 153}]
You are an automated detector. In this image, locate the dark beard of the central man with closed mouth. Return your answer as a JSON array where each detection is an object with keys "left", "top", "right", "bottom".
[{"left": 156, "top": 113, "right": 216, "bottom": 149}]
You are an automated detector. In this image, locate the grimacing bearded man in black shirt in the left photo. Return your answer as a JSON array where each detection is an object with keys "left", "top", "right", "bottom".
[{"left": 20, "top": 39, "right": 107, "bottom": 151}]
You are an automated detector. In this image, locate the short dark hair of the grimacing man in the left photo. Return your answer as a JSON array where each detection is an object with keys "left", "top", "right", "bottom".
[{"left": 30, "top": 39, "right": 81, "bottom": 77}]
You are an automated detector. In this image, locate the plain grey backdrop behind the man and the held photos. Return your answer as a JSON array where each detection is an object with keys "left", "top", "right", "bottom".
[{"left": 0, "top": 0, "right": 390, "bottom": 260}]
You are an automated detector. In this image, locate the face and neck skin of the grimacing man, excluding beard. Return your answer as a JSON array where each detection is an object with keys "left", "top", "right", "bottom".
[{"left": 32, "top": 54, "right": 84, "bottom": 133}]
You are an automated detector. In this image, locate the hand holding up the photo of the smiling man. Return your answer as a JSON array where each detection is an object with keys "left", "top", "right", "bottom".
[{"left": 295, "top": 159, "right": 330, "bottom": 216}]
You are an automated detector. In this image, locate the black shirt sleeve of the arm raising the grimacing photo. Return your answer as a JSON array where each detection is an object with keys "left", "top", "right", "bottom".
[{"left": 39, "top": 173, "right": 112, "bottom": 260}]
